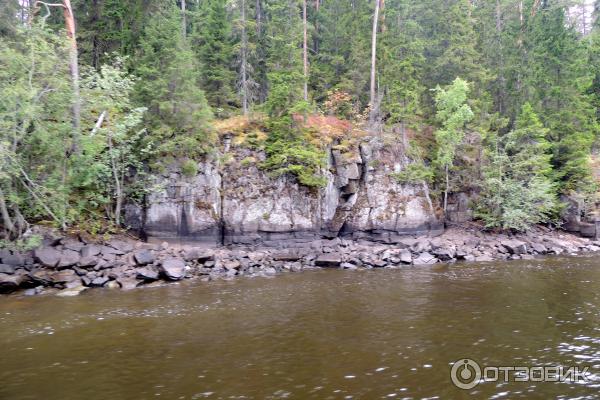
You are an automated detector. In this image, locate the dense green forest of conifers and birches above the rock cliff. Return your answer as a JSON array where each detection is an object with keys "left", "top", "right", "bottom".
[{"left": 0, "top": 0, "right": 600, "bottom": 239}]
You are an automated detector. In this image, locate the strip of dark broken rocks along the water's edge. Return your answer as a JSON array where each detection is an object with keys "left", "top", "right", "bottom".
[{"left": 0, "top": 228, "right": 600, "bottom": 296}]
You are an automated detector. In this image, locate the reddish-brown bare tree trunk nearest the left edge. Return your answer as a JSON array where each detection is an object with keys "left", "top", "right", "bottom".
[{"left": 63, "top": 0, "right": 81, "bottom": 154}]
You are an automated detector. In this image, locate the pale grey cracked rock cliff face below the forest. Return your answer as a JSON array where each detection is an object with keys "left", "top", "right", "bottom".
[{"left": 127, "top": 141, "right": 443, "bottom": 246}]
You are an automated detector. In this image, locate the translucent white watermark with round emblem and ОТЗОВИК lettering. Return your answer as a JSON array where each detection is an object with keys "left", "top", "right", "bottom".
[{"left": 450, "top": 358, "right": 590, "bottom": 390}]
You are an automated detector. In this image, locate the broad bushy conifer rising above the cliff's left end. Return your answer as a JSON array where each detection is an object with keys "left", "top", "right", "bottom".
[{"left": 134, "top": 4, "right": 212, "bottom": 157}]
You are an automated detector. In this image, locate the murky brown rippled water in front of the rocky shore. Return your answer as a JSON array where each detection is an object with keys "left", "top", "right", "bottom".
[{"left": 0, "top": 256, "right": 600, "bottom": 400}]
